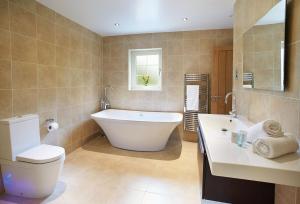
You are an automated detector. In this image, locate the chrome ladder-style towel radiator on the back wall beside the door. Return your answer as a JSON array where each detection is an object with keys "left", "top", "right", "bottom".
[{"left": 183, "top": 74, "right": 209, "bottom": 132}]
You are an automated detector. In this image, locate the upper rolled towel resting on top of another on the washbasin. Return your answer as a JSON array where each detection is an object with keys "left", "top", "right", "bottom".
[{"left": 247, "top": 120, "right": 283, "bottom": 143}]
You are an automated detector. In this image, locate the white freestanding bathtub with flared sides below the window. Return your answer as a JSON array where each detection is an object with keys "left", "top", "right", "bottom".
[{"left": 91, "top": 109, "right": 182, "bottom": 151}]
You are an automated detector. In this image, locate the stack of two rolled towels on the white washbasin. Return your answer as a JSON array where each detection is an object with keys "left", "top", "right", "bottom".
[{"left": 247, "top": 120, "right": 299, "bottom": 159}]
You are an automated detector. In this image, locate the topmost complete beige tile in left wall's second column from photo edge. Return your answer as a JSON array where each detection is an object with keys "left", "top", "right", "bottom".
[{"left": 10, "top": 4, "right": 36, "bottom": 37}]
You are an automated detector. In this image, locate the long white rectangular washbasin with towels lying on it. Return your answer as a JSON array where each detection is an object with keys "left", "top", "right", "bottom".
[{"left": 198, "top": 114, "right": 300, "bottom": 187}]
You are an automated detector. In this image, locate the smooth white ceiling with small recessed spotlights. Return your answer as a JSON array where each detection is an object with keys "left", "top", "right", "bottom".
[{"left": 38, "top": 0, "right": 234, "bottom": 36}]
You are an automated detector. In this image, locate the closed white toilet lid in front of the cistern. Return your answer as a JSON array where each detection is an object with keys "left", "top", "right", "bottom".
[{"left": 16, "top": 144, "right": 65, "bottom": 164}]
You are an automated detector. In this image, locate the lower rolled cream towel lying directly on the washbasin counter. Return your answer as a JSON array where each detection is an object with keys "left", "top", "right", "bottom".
[{"left": 253, "top": 136, "right": 299, "bottom": 159}]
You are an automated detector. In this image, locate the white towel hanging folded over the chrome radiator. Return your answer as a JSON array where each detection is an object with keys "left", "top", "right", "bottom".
[{"left": 186, "top": 85, "right": 199, "bottom": 111}]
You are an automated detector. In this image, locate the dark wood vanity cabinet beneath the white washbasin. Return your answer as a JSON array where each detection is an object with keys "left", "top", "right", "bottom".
[{"left": 198, "top": 130, "right": 275, "bottom": 204}]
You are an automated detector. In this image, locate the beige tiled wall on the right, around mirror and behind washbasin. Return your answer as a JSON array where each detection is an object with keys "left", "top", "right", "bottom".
[{"left": 234, "top": 0, "right": 300, "bottom": 204}]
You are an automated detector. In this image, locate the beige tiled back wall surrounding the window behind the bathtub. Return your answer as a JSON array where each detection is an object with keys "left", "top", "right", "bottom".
[{"left": 103, "top": 30, "right": 233, "bottom": 112}]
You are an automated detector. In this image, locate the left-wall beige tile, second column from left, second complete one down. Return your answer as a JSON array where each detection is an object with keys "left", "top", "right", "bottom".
[{"left": 12, "top": 34, "right": 37, "bottom": 63}]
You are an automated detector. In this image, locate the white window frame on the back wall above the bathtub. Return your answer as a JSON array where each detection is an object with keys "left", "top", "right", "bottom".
[{"left": 128, "top": 48, "right": 162, "bottom": 91}]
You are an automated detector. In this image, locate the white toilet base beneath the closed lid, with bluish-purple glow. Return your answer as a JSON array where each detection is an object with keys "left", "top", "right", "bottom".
[{"left": 0, "top": 157, "right": 65, "bottom": 198}]
